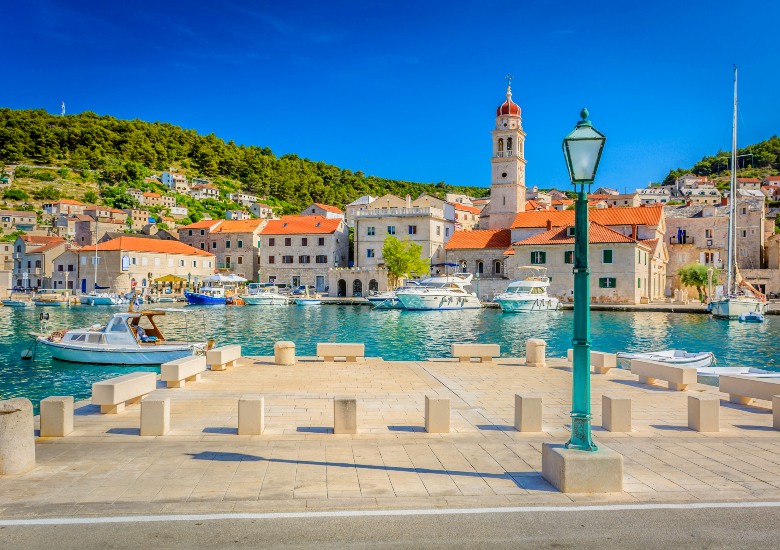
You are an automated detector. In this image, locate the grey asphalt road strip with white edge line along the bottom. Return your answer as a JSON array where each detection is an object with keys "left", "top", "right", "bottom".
[{"left": 0, "top": 507, "right": 780, "bottom": 550}]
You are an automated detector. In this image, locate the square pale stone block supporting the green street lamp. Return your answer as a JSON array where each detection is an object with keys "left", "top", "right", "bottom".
[{"left": 542, "top": 443, "right": 623, "bottom": 493}]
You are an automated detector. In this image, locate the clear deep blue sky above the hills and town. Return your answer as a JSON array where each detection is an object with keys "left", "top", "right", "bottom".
[{"left": 0, "top": 0, "right": 780, "bottom": 190}]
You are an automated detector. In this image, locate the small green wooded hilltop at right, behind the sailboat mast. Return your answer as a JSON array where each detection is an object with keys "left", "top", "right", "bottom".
[{"left": 664, "top": 136, "right": 780, "bottom": 185}]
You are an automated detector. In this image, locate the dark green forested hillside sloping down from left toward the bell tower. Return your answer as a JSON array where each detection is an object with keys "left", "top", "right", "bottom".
[{"left": 0, "top": 108, "right": 488, "bottom": 208}]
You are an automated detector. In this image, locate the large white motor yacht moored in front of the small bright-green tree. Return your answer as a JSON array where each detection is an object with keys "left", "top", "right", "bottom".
[{"left": 396, "top": 273, "right": 482, "bottom": 310}]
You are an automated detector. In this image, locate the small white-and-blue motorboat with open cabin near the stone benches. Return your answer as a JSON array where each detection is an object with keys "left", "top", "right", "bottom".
[{"left": 34, "top": 310, "right": 208, "bottom": 365}]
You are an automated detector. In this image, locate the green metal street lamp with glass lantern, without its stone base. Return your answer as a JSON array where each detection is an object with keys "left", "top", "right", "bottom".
[{"left": 563, "top": 109, "right": 607, "bottom": 451}]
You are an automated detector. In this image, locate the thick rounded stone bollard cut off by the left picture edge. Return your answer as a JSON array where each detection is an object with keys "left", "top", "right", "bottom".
[{"left": 0, "top": 397, "right": 35, "bottom": 475}]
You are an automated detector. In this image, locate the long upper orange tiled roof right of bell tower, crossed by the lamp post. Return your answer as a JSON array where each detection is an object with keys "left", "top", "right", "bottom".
[{"left": 512, "top": 205, "right": 663, "bottom": 229}]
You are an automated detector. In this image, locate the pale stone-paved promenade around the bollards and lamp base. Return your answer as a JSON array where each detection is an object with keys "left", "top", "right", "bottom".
[{"left": 0, "top": 357, "right": 780, "bottom": 518}]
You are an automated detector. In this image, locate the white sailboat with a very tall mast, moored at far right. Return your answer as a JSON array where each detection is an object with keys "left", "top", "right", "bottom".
[{"left": 707, "top": 66, "right": 769, "bottom": 320}]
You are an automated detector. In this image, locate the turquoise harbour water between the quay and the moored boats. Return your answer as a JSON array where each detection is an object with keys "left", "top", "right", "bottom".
[{"left": 0, "top": 306, "right": 780, "bottom": 410}]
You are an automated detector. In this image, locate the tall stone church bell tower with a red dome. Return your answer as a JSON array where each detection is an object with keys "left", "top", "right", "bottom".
[{"left": 488, "top": 77, "right": 525, "bottom": 229}]
